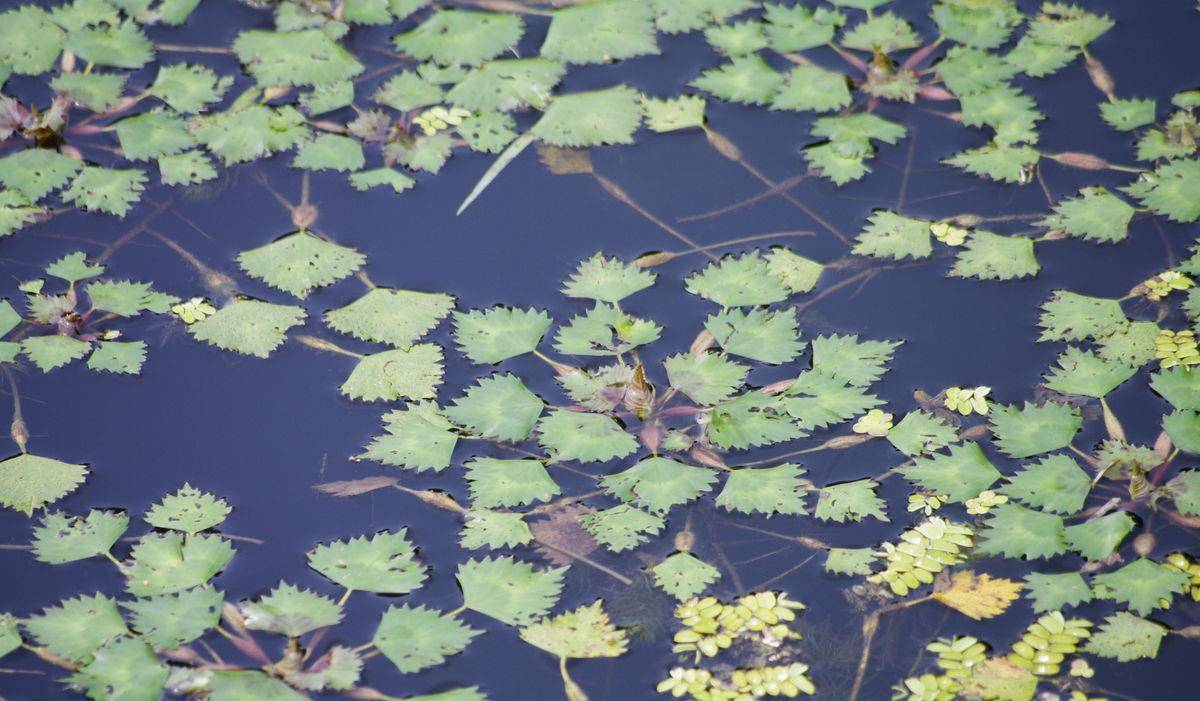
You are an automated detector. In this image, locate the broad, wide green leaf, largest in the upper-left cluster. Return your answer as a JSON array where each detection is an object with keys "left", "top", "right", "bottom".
[{"left": 233, "top": 29, "right": 362, "bottom": 86}]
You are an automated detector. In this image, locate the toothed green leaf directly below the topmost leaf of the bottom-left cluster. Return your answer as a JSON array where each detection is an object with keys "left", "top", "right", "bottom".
[{"left": 125, "top": 532, "right": 234, "bottom": 597}]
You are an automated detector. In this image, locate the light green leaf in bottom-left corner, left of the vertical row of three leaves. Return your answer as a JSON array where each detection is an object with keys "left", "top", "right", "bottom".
[{"left": 25, "top": 593, "right": 128, "bottom": 660}]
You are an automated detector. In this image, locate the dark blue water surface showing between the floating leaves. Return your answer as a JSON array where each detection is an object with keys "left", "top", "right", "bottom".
[{"left": 0, "top": 0, "right": 1200, "bottom": 701}]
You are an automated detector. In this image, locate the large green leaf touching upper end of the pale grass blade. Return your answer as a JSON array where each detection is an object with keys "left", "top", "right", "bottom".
[{"left": 530, "top": 85, "right": 642, "bottom": 148}]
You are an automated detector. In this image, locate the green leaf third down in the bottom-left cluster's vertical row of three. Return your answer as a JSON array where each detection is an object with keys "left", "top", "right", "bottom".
[{"left": 122, "top": 587, "right": 222, "bottom": 649}]
